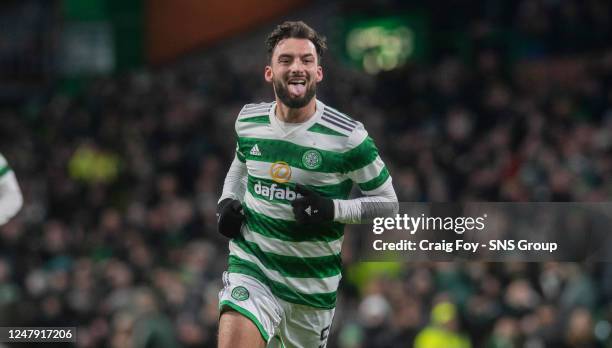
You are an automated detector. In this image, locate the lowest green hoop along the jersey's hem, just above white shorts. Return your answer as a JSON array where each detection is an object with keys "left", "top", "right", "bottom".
[{"left": 228, "top": 255, "right": 336, "bottom": 309}]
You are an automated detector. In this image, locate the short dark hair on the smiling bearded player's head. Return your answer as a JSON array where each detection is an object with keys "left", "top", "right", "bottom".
[{"left": 266, "top": 21, "right": 327, "bottom": 64}]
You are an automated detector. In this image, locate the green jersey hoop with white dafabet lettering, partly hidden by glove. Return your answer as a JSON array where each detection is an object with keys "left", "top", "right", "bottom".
[{"left": 247, "top": 175, "right": 353, "bottom": 204}]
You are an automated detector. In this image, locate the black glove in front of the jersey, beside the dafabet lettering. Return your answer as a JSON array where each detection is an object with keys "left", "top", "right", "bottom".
[{"left": 291, "top": 185, "right": 334, "bottom": 224}]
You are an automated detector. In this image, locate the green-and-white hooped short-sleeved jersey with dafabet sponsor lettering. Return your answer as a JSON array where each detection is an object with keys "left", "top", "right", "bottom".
[{"left": 229, "top": 101, "right": 390, "bottom": 309}]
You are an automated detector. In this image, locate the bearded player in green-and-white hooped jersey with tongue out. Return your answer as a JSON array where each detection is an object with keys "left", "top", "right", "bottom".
[{"left": 218, "top": 21, "right": 397, "bottom": 348}]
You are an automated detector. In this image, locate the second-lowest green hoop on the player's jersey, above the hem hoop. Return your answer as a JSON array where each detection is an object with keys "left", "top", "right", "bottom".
[{"left": 232, "top": 238, "right": 342, "bottom": 278}]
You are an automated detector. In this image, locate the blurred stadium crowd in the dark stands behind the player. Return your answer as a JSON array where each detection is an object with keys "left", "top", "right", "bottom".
[{"left": 0, "top": 0, "right": 612, "bottom": 348}]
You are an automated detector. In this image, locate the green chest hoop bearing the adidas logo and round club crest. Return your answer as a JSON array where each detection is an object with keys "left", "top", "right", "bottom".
[{"left": 238, "top": 137, "right": 378, "bottom": 173}]
